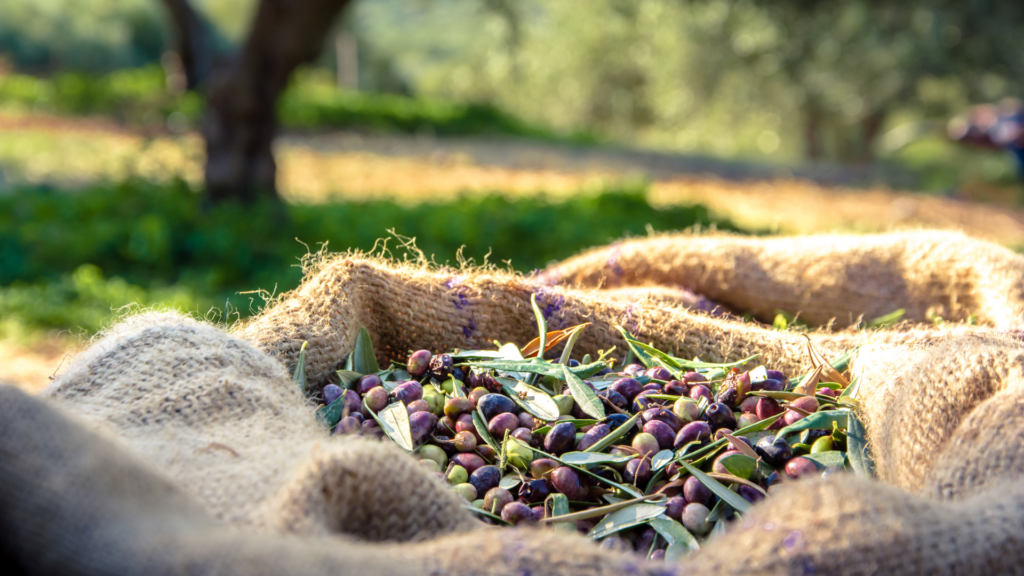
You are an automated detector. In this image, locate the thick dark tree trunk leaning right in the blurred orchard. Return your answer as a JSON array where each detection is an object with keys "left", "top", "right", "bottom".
[{"left": 203, "top": 0, "right": 349, "bottom": 202}]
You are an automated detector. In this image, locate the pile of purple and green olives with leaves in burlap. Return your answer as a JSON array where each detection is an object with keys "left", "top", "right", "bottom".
[{"left": 313, "top": 330, "right": 856, "bottom": 559}]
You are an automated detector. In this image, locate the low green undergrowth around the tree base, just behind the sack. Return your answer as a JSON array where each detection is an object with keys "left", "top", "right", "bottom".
[{"left": 0, "top": 177, "right": 737, "bottom": 331}]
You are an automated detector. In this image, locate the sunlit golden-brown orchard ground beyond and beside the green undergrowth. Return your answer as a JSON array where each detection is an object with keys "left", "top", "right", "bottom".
[{"left": 8, "top": 114, "right": 1024, "bottom": 392}]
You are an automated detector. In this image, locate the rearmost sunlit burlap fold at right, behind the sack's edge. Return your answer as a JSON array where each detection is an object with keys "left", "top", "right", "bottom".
[{"left": 541, "top": 231, "right": 1024, "bottom": 328}]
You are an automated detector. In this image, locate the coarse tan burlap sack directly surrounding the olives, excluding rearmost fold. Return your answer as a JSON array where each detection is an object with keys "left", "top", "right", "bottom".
[{"left": 6, "top": 230, "right": 1024, "bottom": 576}]
